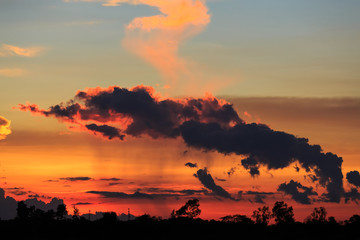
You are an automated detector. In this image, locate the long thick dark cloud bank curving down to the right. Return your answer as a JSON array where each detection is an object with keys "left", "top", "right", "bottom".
[{"left": 180, "top": 121, "right": 344, "bottom": 202}]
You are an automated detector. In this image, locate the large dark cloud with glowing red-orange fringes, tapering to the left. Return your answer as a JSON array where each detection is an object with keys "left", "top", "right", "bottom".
[{"left": 19, "top": 86, "right": 242, "bottom": 139}]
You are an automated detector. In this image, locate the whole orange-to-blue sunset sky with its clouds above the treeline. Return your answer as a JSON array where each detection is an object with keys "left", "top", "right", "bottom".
[{"left": 0, "top": 0, "right": 360, "bottom": 221}]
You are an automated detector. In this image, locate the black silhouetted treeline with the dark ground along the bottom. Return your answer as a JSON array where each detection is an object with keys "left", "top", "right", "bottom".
[{"left": 0, "top": 199, "right": 360, "bottom": 240}]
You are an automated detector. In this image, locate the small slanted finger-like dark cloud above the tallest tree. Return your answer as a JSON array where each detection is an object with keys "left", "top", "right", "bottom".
[{"left": 194, "top": 168, "right": 234, "bottom": 200}]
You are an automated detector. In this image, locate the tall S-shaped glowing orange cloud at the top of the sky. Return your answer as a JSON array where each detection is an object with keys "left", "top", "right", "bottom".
[{"left": 64, "top": 0, "right": 210, "bottom": 87}]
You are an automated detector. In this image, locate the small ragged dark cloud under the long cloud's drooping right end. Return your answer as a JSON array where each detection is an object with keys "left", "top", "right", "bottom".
[{"left": 278, "top": 180, "right": 318, "bottom": 204}]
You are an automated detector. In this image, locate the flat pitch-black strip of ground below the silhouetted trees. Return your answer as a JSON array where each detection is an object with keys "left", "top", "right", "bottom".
[{"left": 0, "top": 218, "right": 360, "bottom": 239}]
